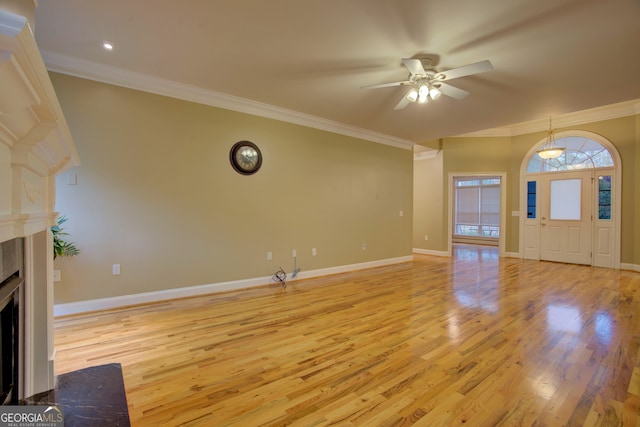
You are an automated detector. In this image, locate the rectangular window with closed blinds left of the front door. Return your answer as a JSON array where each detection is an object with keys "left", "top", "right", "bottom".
[{"left": 453, "top": 177, "right": 500, "bottom": 239}]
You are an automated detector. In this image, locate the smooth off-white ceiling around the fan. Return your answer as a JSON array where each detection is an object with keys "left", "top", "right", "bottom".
[{"left": 35, "top": 0, "right": 640, "bottom": 147}]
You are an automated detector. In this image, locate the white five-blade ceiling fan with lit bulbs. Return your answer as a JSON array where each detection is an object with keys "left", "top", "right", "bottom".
[{"left": 363, "top": 58, "right": 493, "bottom": 110}]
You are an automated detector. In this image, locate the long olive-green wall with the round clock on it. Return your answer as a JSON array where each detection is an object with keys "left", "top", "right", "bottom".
[{"left": 51, "top": 74, "right": 413, "bottom": 304}]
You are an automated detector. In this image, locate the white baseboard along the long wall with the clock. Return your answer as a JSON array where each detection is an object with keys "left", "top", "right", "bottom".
[{"left": 53, "top": 255, "right": 413, "bottom": 316}]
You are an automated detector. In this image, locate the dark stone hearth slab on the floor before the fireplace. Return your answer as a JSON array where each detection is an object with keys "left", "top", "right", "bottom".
[{"left": 23, "top": 363, "right": 131, "bottom": 427}]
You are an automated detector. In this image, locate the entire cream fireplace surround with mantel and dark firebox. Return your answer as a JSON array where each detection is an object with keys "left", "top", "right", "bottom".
[{"left": 0, "top": 0, "right": 79, "bottom": 403}]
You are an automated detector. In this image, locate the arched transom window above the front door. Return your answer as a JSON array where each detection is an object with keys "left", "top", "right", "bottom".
[{"left": 527, "top": 136, "right": 613, "bottom": 173}]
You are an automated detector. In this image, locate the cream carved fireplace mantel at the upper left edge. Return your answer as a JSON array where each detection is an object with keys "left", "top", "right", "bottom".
[{"left": 0, "top": 9, "right": 79, "bottom": 242}]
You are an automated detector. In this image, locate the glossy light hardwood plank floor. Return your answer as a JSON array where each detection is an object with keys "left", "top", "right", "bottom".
[{"left": 55, "top": 246, "right": 640, "bottom": 427}]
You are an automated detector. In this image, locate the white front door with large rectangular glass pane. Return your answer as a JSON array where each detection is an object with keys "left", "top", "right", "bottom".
[{"left": 540, "top": 171, "right": 593, "bottom": 265}]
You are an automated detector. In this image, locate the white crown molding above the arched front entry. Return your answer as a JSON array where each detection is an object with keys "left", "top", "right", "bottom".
[{"left": 456, "top": 99, "right": 640, "bottom": 138}]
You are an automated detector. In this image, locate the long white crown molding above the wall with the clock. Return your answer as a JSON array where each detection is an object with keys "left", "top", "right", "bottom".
[{"left": 41, "top": 51, "right": 414, "bottom": 150}]
